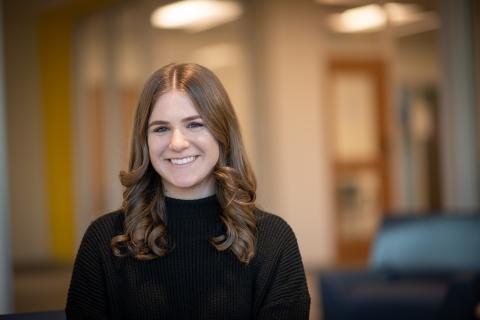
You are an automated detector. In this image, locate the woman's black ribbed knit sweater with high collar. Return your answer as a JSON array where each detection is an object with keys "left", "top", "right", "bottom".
[{"left": 66, "top": 196, "right": 310, "bottom": 320}]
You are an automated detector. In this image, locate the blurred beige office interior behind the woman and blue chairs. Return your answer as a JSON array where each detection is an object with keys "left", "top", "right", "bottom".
[{"left": 0, "top": 0, "right": 480, "bottom": 319}]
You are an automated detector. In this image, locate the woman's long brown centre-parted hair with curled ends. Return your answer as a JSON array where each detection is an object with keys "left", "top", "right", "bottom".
[{"left": 111, "top": 63, "right": 256, "bottom": 263}]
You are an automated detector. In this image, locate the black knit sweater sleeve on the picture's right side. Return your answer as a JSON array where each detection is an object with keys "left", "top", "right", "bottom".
[{"left": 257, "top": 214, "right": 310, "bottom": 320}]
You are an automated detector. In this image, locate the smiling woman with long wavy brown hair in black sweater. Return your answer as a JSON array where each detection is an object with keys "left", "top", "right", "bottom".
[{"left": 66, "top": 64, "right": 310, "bottom": 320}]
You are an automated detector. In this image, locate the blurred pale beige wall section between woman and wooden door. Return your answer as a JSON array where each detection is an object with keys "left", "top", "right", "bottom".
[{"left": 251, "top": 0, "right": 334, "bottom": 267}]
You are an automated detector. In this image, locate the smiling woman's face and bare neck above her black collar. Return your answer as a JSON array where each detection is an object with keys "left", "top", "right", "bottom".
[{"left": 148, "top": 90, "right": 220, "bottom": 199}]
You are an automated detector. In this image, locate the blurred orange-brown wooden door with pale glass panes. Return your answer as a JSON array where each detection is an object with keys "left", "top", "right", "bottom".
[{"left": 329, "top": 60, "right": 390, "bottom": 265}]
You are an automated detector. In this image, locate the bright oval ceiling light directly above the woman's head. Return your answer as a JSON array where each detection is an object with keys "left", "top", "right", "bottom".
[{"left": 150, "top": 0, "right": 242, "bottom": 32}]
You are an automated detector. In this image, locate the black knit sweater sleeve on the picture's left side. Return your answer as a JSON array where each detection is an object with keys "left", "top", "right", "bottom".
[{"left": 65, "top": 221, "right": 109, "bottom": 320}]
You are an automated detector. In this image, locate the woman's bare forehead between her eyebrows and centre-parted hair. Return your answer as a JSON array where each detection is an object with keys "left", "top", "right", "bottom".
[{"left": 150, "top": 90, "right": 198, "bottom": 120}]
